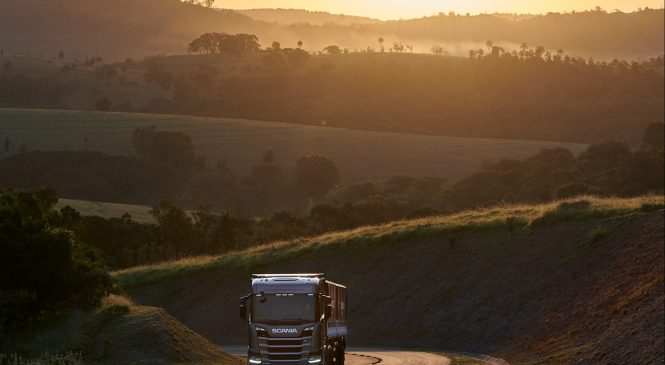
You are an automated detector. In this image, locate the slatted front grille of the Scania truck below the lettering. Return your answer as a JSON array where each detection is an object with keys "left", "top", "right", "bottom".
[{"left": 259, "top": 336, "right": 312, "bottom": 364}]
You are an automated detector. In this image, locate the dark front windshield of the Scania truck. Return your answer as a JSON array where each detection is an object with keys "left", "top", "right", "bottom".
[{"left": 252, "top": 294, "right": 316, "bottom": 323}]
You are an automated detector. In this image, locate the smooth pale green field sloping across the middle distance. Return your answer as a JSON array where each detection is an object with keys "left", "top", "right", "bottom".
[{"left": 0, "top": 109, "right": 586, "bottom": 183}]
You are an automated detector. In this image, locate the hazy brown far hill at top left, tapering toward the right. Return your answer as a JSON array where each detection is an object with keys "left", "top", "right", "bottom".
[{"left": 0, "top": 0, "right": 272, "bottom": 60}]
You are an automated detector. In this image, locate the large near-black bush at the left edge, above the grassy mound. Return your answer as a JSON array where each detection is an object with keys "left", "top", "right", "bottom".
[{"left": 0, "top": 191, "right": 112, "bottom": 330}]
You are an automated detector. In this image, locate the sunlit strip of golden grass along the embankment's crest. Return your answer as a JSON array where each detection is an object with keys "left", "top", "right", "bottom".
[{"left": 113, "top": 195, "right": 665, "bottom": 288}]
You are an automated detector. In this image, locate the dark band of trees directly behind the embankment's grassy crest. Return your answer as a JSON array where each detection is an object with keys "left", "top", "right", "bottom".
[{"left": 1, "top": 123, "right": 665, "bottom": 268}]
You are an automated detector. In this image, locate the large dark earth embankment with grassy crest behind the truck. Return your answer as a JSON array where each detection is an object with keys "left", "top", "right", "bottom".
[{"left": 115, "top": 196, "right": 665, "bottom": 364}]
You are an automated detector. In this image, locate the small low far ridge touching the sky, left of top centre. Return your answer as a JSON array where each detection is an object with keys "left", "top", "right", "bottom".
[{"left": 235, "top": 9, "right": 381, "bottom": 25}]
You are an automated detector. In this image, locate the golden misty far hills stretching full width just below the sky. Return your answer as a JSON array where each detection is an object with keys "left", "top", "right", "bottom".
[{"left": 0, "top": 0, "right": 665, "bottom": 60}]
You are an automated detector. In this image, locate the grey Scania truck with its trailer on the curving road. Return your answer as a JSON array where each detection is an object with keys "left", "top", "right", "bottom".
[{"left": 240, "top": 274, "right": 348, "bottom": 365}]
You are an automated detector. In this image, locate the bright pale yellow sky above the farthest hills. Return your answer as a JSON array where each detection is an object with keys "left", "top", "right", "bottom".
[{"left": 215, "top": 0, "right": 663, "bottom": 19}]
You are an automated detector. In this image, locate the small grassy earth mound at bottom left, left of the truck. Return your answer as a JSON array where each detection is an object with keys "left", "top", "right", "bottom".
[{"left": 0, "top": 295, "right": 242, "bottom": 365}]
